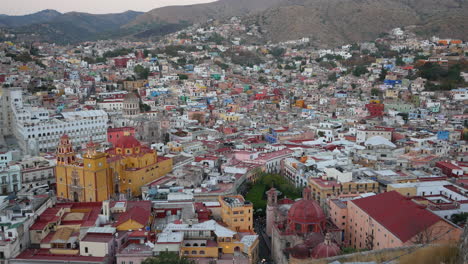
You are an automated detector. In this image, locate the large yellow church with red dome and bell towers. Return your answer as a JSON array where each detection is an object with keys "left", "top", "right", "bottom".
[{"left": 55, "top": 135, "right": 172, "bottom": 202}]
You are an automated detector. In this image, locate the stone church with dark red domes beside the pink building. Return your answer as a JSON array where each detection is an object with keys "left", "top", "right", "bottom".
[{"left": 266, "top": 187, "right": 341, "bottom": 264}]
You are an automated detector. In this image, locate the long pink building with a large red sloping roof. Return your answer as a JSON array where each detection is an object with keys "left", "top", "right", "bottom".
[{"left": 329, "top": 191, "right": 462, "bottom": 249}]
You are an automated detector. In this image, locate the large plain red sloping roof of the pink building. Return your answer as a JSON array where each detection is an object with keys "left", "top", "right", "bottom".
[{"left": 350, "top": 191, "right": 441, "bottom": 242}]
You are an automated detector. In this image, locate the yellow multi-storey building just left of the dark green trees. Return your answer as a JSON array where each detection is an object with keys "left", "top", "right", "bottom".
[{"left": 218, "top": 195, "right": 253, "bottom": 232}]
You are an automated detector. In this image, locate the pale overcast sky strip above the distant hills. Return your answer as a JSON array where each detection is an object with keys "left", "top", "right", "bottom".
[{"left": 0, "top": 0, "right": 214, "bottom": 15}]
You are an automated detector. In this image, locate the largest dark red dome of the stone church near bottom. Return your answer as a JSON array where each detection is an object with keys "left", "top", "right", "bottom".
[{"left": 288, "top": 199, "right": 326, "bottom": 224}]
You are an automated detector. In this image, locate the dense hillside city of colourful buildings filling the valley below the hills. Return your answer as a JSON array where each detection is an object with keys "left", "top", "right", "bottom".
[{"left": 0, "top": 14, "right": 468, "bottom": 264}]
